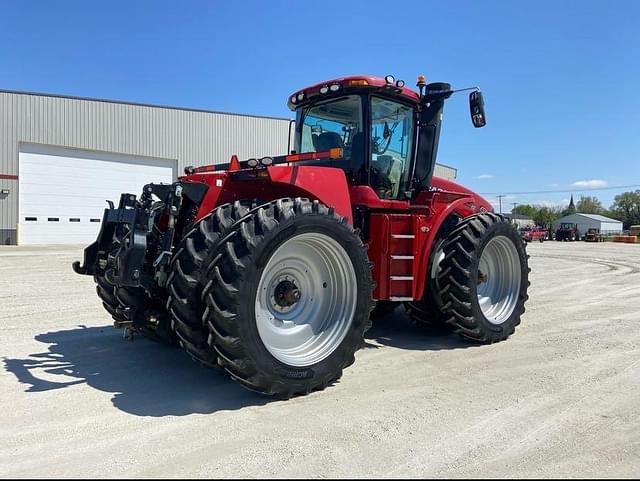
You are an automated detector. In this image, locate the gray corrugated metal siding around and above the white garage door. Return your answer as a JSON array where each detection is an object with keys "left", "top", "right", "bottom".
[{"left": 0, "top": 92, "right": 289, "bottom": 233}]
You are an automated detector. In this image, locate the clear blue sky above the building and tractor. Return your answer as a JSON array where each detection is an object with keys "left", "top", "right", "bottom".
[{"left": 0, "top": 0, "right": 640, "bottom": 210}]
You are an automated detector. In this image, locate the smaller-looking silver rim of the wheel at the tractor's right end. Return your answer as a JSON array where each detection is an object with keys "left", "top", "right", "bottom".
[{"left": 477, "top": 236, "right": 522, "bottom": 325}]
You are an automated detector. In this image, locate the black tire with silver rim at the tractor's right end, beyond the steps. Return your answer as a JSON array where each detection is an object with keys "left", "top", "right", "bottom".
[{"left": 439, "top": 213, "right": 530, "bottom": 344}]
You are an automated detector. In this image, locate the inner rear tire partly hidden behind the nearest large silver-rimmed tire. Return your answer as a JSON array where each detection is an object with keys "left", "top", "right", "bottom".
[{"left": 167, "top": 201, "right": 256, "bottom": 367}]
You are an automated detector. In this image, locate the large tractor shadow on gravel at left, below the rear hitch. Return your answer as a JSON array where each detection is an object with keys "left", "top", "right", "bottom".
[{"left": 4, "top": 326, "right": 272, "bottom": 417}]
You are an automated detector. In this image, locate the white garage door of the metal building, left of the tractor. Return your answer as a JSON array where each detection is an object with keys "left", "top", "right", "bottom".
[{"left": 19, "top": 146, "right": 176, "bottom": 245}]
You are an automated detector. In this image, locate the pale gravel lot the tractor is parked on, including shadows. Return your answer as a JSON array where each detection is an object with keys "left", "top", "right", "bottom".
[{"left": 0, "top": 242, "right": 640, "bottom": 477}]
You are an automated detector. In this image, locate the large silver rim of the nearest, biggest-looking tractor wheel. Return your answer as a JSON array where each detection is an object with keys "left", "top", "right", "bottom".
[{"left": 255, "top": 233, "right": 357, "bottom": 367}]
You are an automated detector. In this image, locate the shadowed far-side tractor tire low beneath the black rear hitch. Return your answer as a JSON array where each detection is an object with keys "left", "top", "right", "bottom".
[{"left": 93, "top": 276, "right": 176, "bottom": 345}]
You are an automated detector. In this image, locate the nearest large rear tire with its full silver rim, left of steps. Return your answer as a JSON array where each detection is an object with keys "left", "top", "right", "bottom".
[{"left": 204, "top": 198, "right": 373, "bottom": 398}]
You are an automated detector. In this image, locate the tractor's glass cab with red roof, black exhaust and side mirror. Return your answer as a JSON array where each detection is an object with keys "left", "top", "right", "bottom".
[{"left": 289, "top": 75, "right": 484, "bottom": 200}]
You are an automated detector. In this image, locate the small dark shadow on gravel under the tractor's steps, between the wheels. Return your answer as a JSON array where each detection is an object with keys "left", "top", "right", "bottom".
[{"left": 364, "top": 307, "right": 478, "bottom": 351}]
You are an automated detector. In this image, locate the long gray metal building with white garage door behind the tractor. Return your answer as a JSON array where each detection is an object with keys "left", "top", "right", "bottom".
[{"left": 0, "top": 90, "right": 457, "bottom": 244}]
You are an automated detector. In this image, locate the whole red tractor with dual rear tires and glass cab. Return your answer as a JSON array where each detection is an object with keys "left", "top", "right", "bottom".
[{"left": 73, "top": 76, "right": 529, "bottom": 398}]
